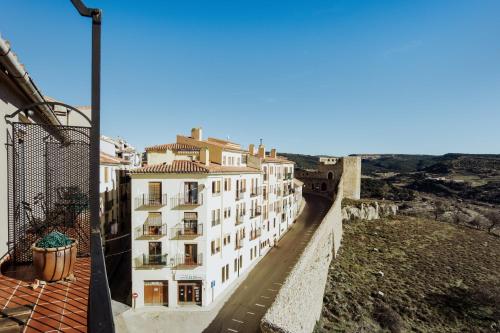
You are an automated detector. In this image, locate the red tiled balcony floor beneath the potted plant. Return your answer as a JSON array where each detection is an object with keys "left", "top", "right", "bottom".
[{"left": 0, "top": 258, "right": 90, "bottom": 332}]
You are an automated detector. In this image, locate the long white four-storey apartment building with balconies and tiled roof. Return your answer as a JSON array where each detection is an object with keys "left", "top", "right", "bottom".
[{"left": 131, "top": 128, "right": 302, "bottom": 307}]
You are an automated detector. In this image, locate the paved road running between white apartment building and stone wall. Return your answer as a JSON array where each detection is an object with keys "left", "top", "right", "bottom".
[{"left": 204, "top": 195, "right": 331, "bottom": 333}]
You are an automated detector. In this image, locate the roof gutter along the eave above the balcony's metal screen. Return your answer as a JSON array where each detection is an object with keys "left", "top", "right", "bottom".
[{"left": 0, "top": 37, "right": 60, "bottom": 125}]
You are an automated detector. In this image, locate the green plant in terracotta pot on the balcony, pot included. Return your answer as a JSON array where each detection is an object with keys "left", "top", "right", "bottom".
[{"left": 31, "top": 231, "right": 78, "bottom": 282}]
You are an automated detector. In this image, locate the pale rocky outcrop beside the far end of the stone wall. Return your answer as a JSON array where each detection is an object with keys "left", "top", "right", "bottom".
[{"left": 342, "top": 201, "right": 398, "bottom": 221}]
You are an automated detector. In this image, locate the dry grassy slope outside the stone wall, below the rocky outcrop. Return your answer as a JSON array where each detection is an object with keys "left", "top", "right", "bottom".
[{"left": 316, "top": 217, "right": 500, "bottom": 332}]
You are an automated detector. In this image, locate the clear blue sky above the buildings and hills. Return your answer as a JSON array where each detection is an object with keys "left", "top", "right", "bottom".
[{"left": 0, "top": 0, "right": 500, "bottom": 155}]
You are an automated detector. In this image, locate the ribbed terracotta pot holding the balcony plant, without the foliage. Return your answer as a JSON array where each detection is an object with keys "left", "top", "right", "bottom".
[{"left": 31, "top": 238, "right": 78, "bottom": 282}]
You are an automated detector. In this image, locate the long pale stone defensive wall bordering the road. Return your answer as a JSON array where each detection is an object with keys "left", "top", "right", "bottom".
[{"left": 260, "top": 175, "right": 344, "bottom": 333}]
